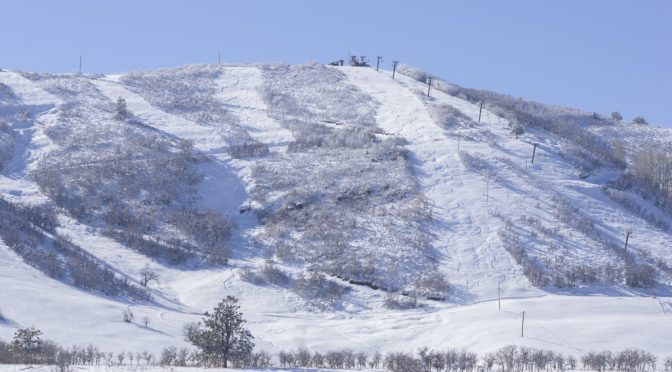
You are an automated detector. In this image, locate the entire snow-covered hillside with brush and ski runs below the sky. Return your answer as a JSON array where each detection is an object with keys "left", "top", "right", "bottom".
[{"left": 0, "top": 64, "right": 672, "bottom": 358}]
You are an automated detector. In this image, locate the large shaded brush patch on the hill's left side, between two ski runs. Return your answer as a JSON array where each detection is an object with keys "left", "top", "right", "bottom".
[{"left": 25, "top": 75, "right": 235, "bottom": 263}]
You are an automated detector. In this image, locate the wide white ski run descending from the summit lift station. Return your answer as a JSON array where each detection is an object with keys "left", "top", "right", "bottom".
[{"left": 342, "top": 68, "right": 528, "bottom": 299}]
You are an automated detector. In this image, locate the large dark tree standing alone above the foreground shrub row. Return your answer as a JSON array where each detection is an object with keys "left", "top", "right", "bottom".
[{"left": 185, "top": 296, "right": 254, "bottom": 368}]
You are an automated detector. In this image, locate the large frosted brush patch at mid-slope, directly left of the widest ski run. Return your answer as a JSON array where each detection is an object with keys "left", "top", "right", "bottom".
[{"left": 253, "top": 147, "right": 436, "bottom": 290}]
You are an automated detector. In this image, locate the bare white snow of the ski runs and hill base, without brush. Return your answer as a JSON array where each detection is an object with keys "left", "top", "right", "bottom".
[{"left": 0, "top": 66, "right": 672, "bottom": 362}]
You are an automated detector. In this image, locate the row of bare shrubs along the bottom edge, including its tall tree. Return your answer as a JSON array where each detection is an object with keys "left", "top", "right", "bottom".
[{"left": 0, "top": 296, "right": 672, "bottom": 372}]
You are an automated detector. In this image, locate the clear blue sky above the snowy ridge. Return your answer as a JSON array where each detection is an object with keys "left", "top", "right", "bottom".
[{"left": 0, "top": 0, "right": 672, "bottom": 126}]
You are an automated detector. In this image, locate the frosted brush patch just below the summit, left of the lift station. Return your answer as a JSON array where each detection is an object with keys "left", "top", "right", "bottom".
[{"left": 260, "top": 63, "right": 376, "bottom": 151}]
